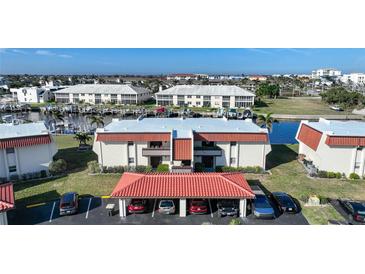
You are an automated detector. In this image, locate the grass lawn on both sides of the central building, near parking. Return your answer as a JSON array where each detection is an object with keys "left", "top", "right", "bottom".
[{"left": 14, "top": 136, "right": 365, "bottom": 224}]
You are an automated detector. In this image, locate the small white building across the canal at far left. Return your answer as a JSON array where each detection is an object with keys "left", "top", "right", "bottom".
[{"left": 10, "top": 87, "right": 54, "bottom": 103}]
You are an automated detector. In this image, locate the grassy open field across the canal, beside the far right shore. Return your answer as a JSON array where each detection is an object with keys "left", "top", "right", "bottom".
[{"left": 254, "top": 97, "right": 351, "bottom": 115}]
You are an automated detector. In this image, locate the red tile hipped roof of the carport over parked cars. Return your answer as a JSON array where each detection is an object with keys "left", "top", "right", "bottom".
[{"left": 111, "top": 172, "right": 255, "bottom": 199}]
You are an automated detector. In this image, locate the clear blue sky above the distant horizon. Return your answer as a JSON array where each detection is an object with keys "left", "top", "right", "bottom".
[{"left": 0, "top": 48, "right": 365, "bottom": 75}]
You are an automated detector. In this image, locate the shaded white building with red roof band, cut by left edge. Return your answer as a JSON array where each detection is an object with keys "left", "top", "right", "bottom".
[{"left": 0, "top": 122, "right": 57, "bottom": 181}]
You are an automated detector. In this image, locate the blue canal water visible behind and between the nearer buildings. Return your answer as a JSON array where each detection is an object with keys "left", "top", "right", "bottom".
[{"left": 2, "top": 112, "right": 299, "bottom": 144}]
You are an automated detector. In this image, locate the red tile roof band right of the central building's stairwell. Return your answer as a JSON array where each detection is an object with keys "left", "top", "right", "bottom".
[{"left": 194, "top": 133, "right": 269, "bottom": 143}]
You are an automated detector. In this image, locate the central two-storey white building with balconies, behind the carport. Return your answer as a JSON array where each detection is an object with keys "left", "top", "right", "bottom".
[{"left": 93, "top": 118, "right": 271, "bottom": 171}]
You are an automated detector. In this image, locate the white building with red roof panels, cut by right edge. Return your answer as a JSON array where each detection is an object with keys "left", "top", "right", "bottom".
[{"left": 296, "top": 118, "right": 365, "bottom": 177}]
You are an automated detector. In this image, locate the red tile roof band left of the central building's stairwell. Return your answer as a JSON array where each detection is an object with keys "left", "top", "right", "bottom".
[{"left": 96, "top": 133, "right": 170, "bottom": 142}]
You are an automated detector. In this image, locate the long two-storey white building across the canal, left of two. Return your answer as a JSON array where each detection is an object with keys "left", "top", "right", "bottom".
[{"left": 55, "top": 84, "right": 151, "bottom": 105}]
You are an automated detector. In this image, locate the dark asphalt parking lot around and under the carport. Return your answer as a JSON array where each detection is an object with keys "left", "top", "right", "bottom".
[{"left": 9, "top": 197, "right": 308, "bottom": 225}]
